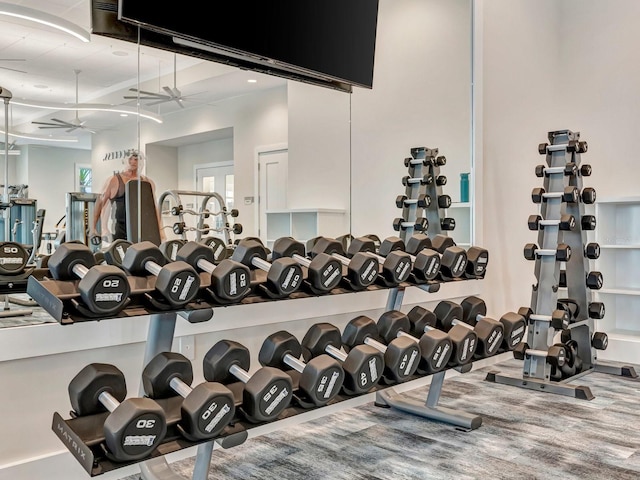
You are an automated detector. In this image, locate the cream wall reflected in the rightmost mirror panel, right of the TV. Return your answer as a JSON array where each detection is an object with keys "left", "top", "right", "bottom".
[{"left": 351, "top": 0, "right": 471, "bottom": 238}]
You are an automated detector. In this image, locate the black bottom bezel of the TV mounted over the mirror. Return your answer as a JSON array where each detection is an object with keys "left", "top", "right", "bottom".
[{"left": 114, "top": 0, "right": 375, "bottom": 93}]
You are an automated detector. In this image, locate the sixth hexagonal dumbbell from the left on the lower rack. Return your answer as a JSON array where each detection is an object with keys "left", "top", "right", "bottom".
[{"left": 342, "top": 315, "right": 420, "bottom": 383}]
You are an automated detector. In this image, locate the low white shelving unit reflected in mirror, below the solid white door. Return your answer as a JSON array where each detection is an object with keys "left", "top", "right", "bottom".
[{"left": 266, "top": 208, "right": 348, "bottom": 248}]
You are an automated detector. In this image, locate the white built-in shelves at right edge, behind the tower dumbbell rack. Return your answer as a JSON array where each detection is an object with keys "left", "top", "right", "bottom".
[{"left": 595, "top": 196, "right": 640, "bottom": 363}]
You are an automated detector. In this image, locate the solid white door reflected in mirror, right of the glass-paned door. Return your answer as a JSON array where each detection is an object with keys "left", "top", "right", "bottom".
[{"left": 258, "top": 149, "right": 289, "bottom": 245}]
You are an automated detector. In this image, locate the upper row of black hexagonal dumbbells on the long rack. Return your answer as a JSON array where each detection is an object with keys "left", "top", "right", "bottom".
[{"left": 30, "top": 234, "right": 488, "bottom": 318}]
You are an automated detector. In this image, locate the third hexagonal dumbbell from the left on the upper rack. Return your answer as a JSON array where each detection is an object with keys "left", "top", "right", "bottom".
[{"left": 176, "top": 242, "right": 251, "bottom": 304}]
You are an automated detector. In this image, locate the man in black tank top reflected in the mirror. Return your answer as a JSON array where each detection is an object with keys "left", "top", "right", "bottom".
[{"left": 91, "top": 152, "right": 161, "bottom": 244}]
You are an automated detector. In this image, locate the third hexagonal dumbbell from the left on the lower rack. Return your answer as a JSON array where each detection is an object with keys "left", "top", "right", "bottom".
[{"left": 202, "top": 340, "right": 293, "bottom": 423}]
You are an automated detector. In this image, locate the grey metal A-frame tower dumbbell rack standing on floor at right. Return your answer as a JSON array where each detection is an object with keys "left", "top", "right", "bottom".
[{"left": 487, "top": 130, "right": 637, "bottom": 400}]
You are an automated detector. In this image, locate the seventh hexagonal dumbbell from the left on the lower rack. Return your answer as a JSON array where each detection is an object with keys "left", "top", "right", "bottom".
[{"left": 377, "top": 310, "right": 453, "bottom": 375}]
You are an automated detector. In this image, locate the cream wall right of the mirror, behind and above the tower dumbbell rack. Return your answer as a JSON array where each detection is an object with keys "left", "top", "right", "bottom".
[{"left": 480, "top": 0, "right": 640, "bottom": 312}]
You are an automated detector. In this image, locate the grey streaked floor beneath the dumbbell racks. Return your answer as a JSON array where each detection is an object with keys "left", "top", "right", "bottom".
[{"left": 117, "top": 359, "right": 640, "bottom": 480}]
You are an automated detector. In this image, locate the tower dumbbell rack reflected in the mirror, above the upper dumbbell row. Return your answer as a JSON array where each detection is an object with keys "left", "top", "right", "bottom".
[{"left": 397, "top": 147, "right": 455, "bottom": 242}]
